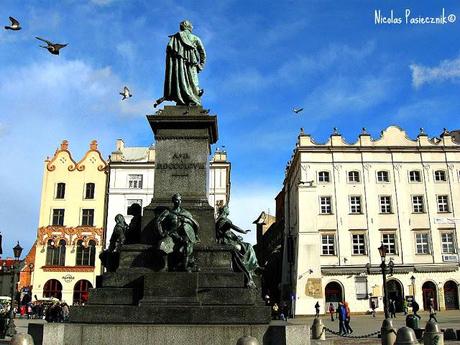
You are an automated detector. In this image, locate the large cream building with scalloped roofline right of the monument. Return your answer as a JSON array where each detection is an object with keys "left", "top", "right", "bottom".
[{"left": 283, "top": 126, "right": 460, "bottom": 315}]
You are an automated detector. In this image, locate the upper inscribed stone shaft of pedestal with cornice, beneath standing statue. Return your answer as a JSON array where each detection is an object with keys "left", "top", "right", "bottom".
[{"left": 142, "top": 106, "right": 218, "bottom": 245}]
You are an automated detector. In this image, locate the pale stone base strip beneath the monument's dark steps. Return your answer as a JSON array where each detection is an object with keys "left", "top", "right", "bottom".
[{"left": 28, "top": 323, "right": 310, "bottom": 345}]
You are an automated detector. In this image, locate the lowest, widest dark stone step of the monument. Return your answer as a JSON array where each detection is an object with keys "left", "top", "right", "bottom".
[{"left": 69, "top": 304, "right": 271, "bottom": 325}]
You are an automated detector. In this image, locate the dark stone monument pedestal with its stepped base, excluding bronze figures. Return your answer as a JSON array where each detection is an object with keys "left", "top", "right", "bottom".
[{"left": 69, "top": 106, "right": 271, "bottom": 326}]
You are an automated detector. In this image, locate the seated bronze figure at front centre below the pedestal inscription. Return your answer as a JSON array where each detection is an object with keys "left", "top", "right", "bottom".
[{"left": 155, "top": 194, "right": 200, "bottom": 272}]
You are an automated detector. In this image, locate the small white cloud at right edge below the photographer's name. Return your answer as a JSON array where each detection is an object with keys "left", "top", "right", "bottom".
[{"left": 409, "top": 57, "right": 460, "bottom": 88}]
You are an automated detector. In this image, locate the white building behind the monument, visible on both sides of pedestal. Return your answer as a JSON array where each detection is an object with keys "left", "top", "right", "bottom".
[{"left": 105, "top": 139, "right": 231, "bottom": 242}]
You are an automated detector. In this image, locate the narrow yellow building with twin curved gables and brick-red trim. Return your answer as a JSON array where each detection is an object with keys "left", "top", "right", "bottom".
[{"left": 32, "top": 140, "right": 107, "bottom": 304}]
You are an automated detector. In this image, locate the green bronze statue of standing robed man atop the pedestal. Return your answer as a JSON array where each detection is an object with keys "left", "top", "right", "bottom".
[{"left": 154, "top": 20, "right": 206, "bottom": 107}]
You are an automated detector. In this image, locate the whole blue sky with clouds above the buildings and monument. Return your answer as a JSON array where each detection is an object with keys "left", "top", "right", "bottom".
[{"left": 0, "top": 0, "right": 460, "bottom": 257}]
